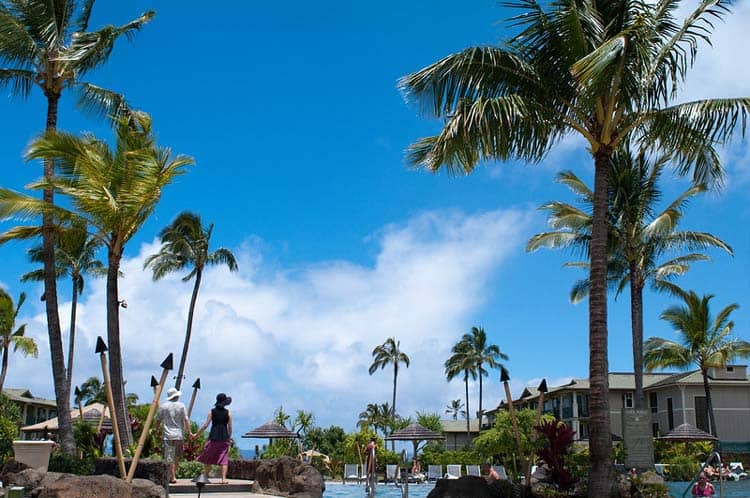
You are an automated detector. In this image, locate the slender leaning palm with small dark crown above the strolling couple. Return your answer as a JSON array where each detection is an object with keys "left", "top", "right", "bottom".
[{"left": 143, "top": 211, "right": 237, "bottom": 389}]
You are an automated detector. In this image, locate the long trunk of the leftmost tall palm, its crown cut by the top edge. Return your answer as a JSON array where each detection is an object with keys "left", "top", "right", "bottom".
[{"left": 42, "top": 93, "right": 76, "bottom": 456}]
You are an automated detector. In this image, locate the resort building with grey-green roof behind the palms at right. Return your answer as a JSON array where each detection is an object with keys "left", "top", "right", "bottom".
[{"left": 486, "top": 365, "right": 750, "bottom": 451}]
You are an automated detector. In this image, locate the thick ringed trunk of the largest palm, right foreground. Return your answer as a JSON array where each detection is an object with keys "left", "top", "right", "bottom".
[{"left": 588, "top": 146, "right": 614, "bottom": 498}]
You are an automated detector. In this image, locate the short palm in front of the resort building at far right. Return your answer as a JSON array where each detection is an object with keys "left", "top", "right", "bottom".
[{"left": 643, "top": 291, "right": 750, "bottom": 437}]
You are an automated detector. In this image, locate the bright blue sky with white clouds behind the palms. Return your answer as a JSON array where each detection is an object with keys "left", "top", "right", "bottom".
[{"left": 0, "top": 0, "right": 750, "bottom": 448}]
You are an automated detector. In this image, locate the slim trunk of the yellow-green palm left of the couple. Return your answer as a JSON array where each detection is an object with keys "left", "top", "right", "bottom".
[{"left": 107, "top": 245, "right": 133, "bottom": 450}]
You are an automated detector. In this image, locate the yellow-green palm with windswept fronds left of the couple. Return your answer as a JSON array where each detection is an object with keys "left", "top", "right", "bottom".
[{"left": 0, "top": 112, "right": 193, "bottom": 448}]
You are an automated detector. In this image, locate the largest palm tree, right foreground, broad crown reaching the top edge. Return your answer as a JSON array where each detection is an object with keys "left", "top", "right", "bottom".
[{"left": 400, "top": 0, "right": 750, "bottom": 492}]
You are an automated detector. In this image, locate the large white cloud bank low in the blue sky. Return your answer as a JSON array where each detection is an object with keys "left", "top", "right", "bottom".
[{"left": 6, "top": 206, "right": 531, "bottom": 444}]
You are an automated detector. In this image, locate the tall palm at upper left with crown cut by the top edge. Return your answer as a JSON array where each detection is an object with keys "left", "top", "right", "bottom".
[{"left": 0, "top": 0, "right": 154, "bottom": 455}]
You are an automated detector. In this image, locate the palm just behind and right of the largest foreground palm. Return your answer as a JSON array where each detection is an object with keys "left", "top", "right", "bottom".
[{"left": 527, "top": 150, "right": 732, "bottom": 409}]
